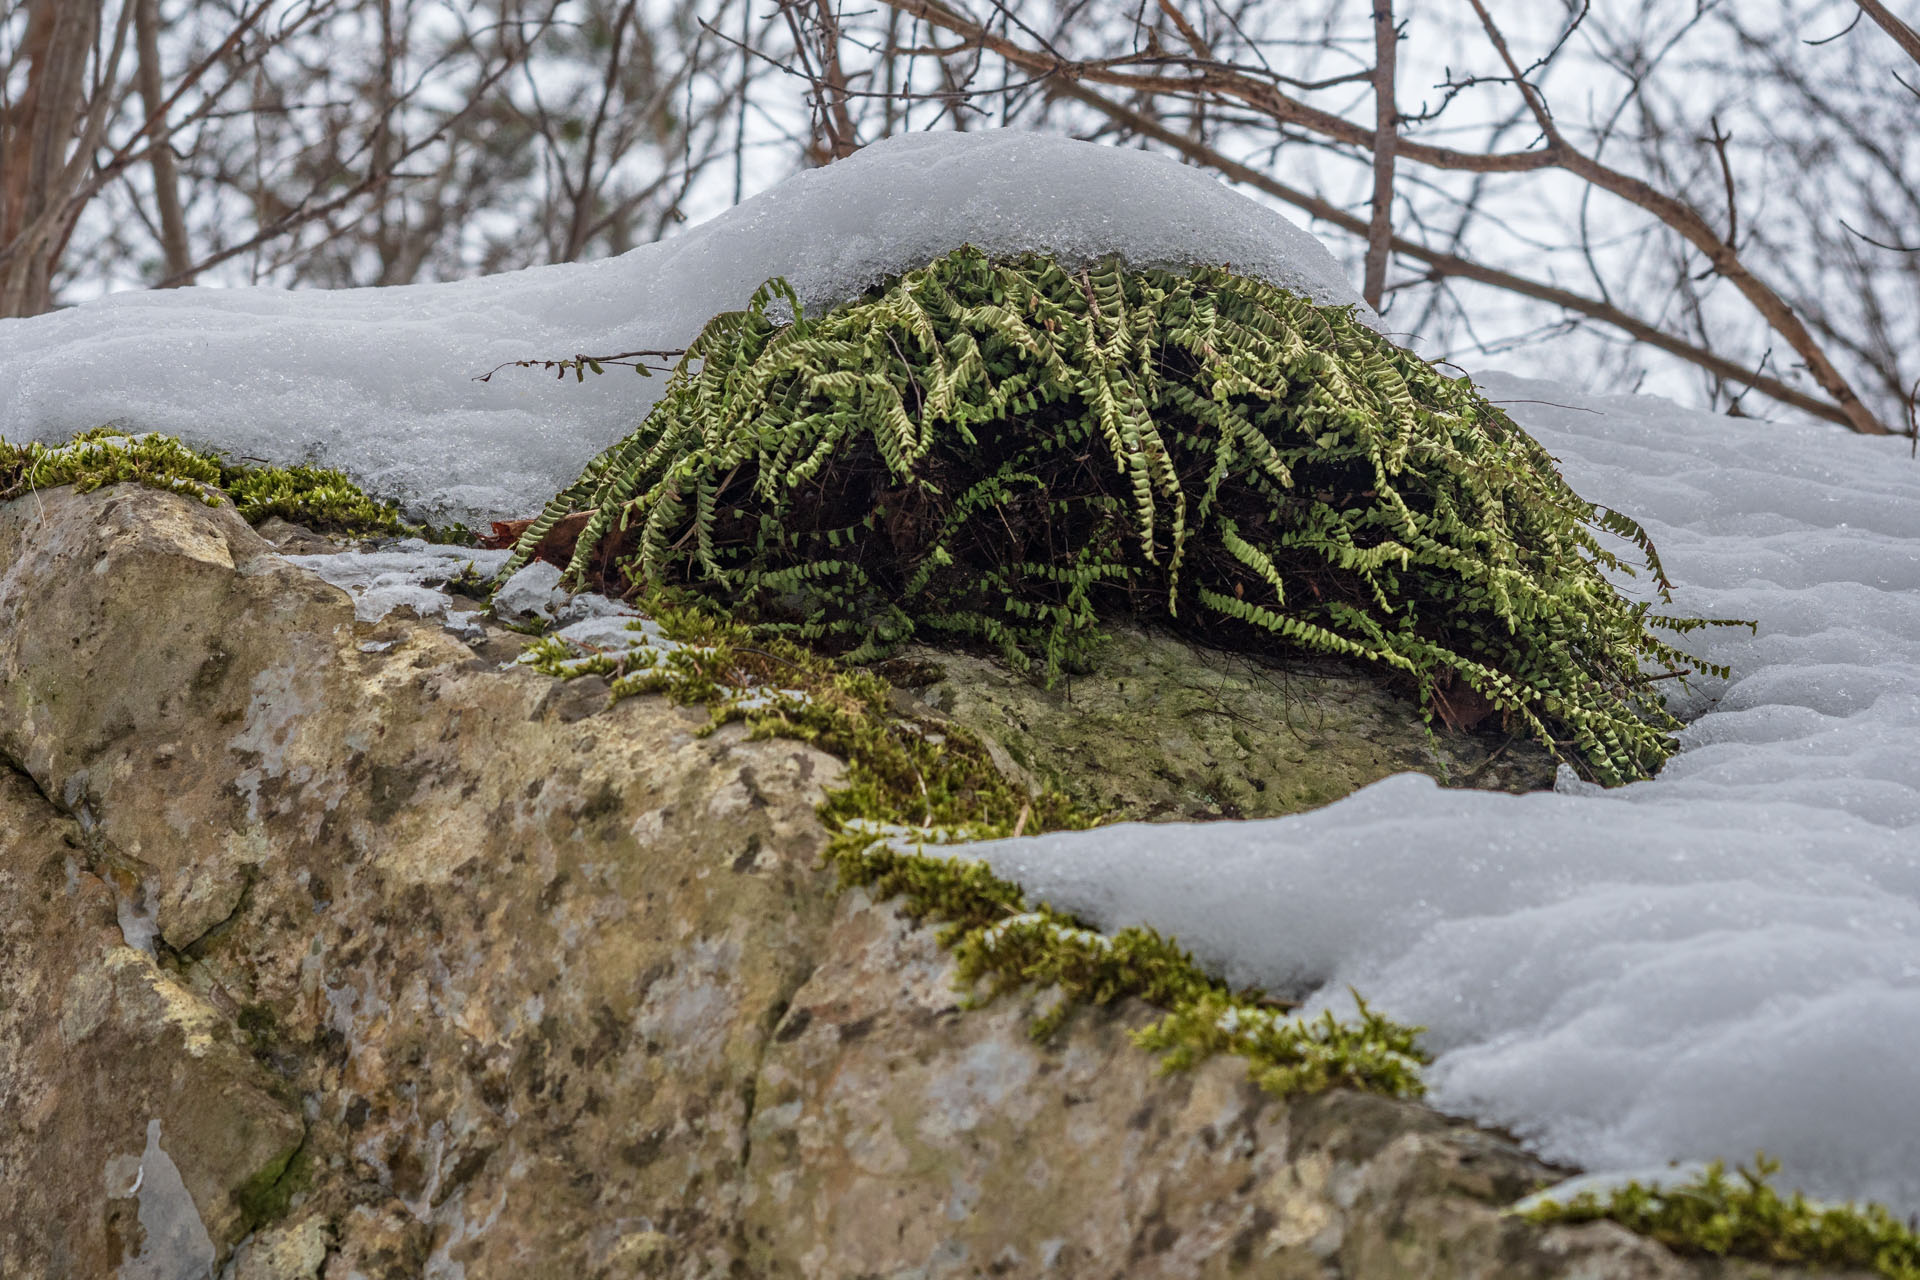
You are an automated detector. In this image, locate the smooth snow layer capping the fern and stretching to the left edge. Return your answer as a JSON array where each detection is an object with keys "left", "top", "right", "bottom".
[{"left": 0, "top": 130, "right": 1371, "bottom": 520}]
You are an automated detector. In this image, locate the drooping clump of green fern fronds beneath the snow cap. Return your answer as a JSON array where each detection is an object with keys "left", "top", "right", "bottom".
[{"left": 509, "top": 239, "right": 1724, "bottom": 783}]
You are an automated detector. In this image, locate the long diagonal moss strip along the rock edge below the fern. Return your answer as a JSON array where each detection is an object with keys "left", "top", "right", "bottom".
[{"left": 528, "top": 595, "right": 1427, "bottom": 1098}]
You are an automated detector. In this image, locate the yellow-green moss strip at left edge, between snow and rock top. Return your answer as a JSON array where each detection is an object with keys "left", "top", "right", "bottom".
[{"left": 0, "top": 426, "right": 474, "bottom": 543}]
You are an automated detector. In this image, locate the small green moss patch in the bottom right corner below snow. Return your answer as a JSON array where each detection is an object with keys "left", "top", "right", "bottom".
[{"left": 1521, "top": 1155, "right": 1920, "bottom": 1280}]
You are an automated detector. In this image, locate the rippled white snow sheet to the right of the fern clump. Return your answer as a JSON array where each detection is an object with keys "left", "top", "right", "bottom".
[{"left": 966, "top": 376, "right": 1920, "bottom": 1213}]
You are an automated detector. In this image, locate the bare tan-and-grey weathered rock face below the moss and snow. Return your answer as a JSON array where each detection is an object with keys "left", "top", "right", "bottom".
[{"left": 0, "top": 486, "right": 1820, "bottom": 1280}]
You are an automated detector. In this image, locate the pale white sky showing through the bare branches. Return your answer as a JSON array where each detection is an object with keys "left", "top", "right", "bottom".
[{"left": 11, "top": 0, "right": 1920, "bottom": 433}]
